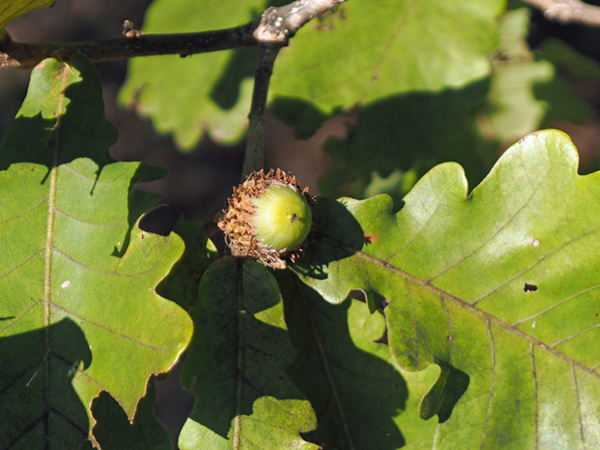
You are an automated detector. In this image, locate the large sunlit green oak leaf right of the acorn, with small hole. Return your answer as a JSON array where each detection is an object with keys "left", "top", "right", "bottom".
[{"left": 303, "top": 130, "right": 600, "bottom": 449}]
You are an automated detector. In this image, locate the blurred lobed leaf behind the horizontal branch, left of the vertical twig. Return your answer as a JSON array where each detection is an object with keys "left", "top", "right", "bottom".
[{"left": 119, "top": 0, "right": 265, "bottom": 150}]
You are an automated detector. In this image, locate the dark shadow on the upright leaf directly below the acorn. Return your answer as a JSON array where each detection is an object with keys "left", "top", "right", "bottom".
[{"left": 181, "top": 256, "right": 314, "bottom": 438}]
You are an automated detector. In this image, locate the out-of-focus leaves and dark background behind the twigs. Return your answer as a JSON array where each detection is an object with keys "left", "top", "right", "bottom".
[{"left": 0, "top": 0, "right": 600, "bottom": 442}]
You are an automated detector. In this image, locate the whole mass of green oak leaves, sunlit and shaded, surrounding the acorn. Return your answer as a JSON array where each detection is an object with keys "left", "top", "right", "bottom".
[{"left": 0, "top": 0, "right": 600, "bottom": 450}]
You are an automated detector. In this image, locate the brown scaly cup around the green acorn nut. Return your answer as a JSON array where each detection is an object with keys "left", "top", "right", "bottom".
[{"left": 217, "top": 169, "right": 314, "bottom": 269}]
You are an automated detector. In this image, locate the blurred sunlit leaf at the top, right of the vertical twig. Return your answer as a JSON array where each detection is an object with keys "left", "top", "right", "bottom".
[{"left": 272, "top": 0, "right": 504, "bottom": 113}]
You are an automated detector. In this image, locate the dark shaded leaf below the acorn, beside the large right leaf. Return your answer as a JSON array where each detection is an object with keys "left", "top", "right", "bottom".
[{"left": 276, "top": 272, "right": 408, "bottom": 450}]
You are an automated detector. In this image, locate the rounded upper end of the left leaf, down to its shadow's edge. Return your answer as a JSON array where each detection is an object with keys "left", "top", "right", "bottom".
[{"left": 0, "top": 55, "right": 118, "bottom": 177}]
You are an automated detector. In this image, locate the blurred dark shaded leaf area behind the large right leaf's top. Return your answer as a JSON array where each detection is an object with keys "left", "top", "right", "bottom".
[{"left": 319, "top": 79, "right": 491, "bottom": 197}]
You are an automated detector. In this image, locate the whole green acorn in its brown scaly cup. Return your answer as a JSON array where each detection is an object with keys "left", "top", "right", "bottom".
[{"left": 217, "top": 169, "right": 313, "bottom": 269}]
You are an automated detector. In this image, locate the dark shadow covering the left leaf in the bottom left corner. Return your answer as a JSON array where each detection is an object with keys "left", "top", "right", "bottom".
[{"left": 0, "top": 319, "right": 92, "bottom": 449}]
